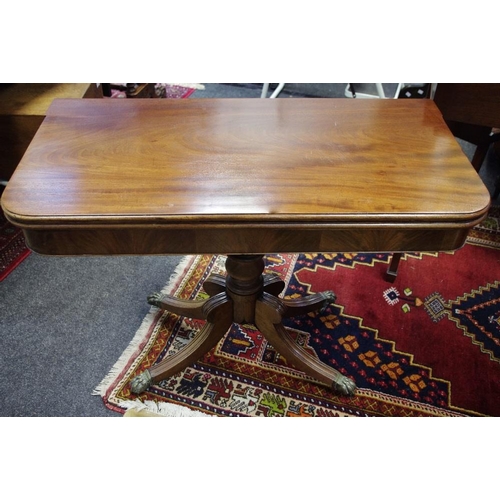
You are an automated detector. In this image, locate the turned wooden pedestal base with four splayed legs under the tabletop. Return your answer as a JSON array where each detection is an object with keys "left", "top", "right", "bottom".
[{"left": 131, "top": 255, "right": 356, "bottom": 395}]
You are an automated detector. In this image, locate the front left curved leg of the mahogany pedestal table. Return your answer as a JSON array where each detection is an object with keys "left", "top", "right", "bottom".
[{"left": 130, "top": 293, "right": 233, "bottom": 394}]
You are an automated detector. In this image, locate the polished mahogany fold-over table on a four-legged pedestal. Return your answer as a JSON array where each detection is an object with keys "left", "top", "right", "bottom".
[{"left": 2, "top": 99, "right": 490, "bottom": 395}]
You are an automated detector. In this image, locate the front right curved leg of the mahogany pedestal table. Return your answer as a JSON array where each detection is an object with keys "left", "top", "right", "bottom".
[{"left": 255, "top": 293, "right": 356, "bottom": 396}]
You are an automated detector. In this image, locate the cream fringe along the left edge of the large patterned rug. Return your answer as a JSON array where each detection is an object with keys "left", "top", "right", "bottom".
[{"left": 92, "top": 255, "right": 193, "bottom": 397}]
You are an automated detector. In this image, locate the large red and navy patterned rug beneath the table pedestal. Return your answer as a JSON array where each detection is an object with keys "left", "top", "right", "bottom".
[{"left": 95, "top": 211, "right": 500, "bottom": 417}]
